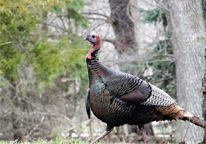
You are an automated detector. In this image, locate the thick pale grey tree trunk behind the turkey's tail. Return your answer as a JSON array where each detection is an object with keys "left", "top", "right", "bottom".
[{"left": 165, "top": 0, "right": 206, "bottom": 144}]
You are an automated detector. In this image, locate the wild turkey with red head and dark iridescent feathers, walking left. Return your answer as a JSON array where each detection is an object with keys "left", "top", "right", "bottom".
[{"left": 85, "top": 33, "right": 205, "bottom": 142}]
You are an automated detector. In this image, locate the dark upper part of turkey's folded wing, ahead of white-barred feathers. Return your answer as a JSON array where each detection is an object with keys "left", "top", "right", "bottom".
[{"left": 104, "top": 71, "right": 151, "bottom": 105}]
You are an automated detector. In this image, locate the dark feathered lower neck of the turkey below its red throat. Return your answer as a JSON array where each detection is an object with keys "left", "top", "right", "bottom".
[{"left": 86, "top": 49, "right": 113, "bottom": 86}]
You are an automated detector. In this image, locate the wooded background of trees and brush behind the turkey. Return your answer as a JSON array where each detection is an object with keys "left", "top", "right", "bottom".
[{"left": 0, "top": 0, "right": 206, "bottom": 144}]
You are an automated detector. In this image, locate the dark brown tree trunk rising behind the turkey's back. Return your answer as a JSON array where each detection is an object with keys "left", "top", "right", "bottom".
[{"left": 109, "top": 0, "right": 138, "bottom": 59}]
